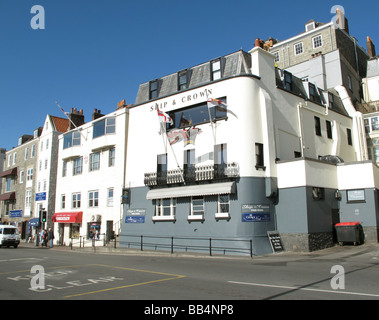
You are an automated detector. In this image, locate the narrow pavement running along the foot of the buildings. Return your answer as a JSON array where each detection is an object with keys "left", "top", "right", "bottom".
[{"left": 19, "top": 241, "right": 379, "bottom": 261}]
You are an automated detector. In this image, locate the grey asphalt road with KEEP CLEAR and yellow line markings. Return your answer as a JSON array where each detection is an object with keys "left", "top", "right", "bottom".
[{"left": 0, "top": 244, "right": 379, "bottom": 308}]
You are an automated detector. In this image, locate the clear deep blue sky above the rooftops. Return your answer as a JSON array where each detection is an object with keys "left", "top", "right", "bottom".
[{"left": 0, "top": 0, "right": 379, "bottom": 150}]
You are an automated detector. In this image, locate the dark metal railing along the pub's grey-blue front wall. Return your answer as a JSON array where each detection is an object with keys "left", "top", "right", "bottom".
[{"left": 119, "top": 234, "right": 253, "bottom": 258}]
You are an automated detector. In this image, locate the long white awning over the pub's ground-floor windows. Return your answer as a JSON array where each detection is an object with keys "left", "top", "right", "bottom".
[{"left": 146, "top": 182, "right": 235, "bottom": 200}]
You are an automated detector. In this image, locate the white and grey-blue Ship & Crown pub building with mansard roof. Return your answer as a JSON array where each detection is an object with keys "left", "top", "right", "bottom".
[{"left": 120, "top": 47, "right": 377, "bottom": 254}]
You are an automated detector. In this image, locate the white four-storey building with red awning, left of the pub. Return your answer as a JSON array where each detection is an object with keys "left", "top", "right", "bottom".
[{"left": 52, "top": 105, "right": 128, "bottom": 245}]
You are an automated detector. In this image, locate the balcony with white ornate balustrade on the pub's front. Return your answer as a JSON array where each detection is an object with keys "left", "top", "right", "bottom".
[{"left": 144, "top": 162, "right": 239, "bottom": 186}]
